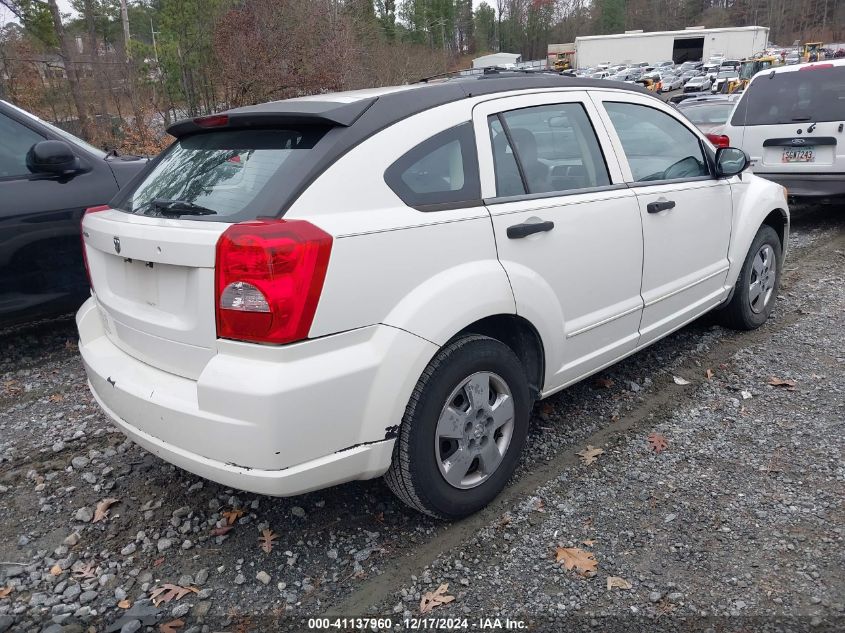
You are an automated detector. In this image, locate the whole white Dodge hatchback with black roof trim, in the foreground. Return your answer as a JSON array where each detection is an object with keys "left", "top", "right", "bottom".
[{"left": 77, "top": 72, "right": 789, "bottom": 518}]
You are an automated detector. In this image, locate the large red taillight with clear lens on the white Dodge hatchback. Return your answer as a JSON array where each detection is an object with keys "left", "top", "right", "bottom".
[{"left": 215, "top": 220, "right": 332, "bottom": 344}]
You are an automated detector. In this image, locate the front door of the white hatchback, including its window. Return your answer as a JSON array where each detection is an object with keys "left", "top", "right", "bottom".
[{"left": 593, "top": 92, "right": 736, "bottom": 346}]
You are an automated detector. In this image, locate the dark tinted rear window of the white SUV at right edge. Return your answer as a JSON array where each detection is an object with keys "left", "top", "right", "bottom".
[{"left": 731, "top": 66, "right": 845, "bottom": 125}]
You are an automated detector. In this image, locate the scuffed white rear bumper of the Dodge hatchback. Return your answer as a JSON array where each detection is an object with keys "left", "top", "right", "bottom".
[{"left": 77, "top": 299, "right": 436, "bottom": 496}]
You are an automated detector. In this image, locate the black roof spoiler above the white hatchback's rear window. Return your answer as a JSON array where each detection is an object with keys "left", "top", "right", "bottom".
[{"left": 167, "top": 97, "right": 377, "bottom": 138}]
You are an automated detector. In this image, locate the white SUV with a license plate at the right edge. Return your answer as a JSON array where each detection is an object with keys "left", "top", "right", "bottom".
[{"left": 723, "top": 59, "right": 845, "bottom": 199}]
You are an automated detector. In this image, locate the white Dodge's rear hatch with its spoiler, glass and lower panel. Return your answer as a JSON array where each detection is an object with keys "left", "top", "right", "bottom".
[{"left": 82, "top": 101, "right": 369, "bottom": 379}]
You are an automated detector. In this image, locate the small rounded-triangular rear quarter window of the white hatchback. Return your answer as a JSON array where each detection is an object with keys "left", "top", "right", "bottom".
[{"left": 384, "top": 122, "right": 481, "bottom": 211}]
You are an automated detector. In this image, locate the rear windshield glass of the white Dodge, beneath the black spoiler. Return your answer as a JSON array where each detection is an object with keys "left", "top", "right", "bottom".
[{"left": 113, "top": 127, "right": 326, "bottom": 221}]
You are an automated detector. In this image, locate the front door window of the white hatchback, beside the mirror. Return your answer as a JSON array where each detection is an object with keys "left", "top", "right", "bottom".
[{"left": 604, "top": 102, "right": 710, "bottom": 182}]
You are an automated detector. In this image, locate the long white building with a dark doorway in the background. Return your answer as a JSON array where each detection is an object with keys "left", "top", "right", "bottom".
[{"left": 575, "top": 26, "right": 769, "bottom": 68}]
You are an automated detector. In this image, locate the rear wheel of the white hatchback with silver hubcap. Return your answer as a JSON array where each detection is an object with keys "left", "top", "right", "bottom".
[{"left": 385, "top": 334, "right": 532, "bottom": 519}]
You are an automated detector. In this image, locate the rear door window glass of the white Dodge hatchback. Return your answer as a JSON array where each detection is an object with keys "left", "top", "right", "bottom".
[{"left": 488, "top": 103, "right": 610, "bottom": 197}]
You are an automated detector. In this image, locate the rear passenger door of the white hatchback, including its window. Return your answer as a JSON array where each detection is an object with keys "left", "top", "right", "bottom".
[{"left": 473, "top": 87, "right": 642, "bottom": 389}]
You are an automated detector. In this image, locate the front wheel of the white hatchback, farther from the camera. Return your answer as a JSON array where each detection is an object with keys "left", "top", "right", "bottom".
[{"left": 719, "top": 224, "right": 783, "bottom": 330}]
